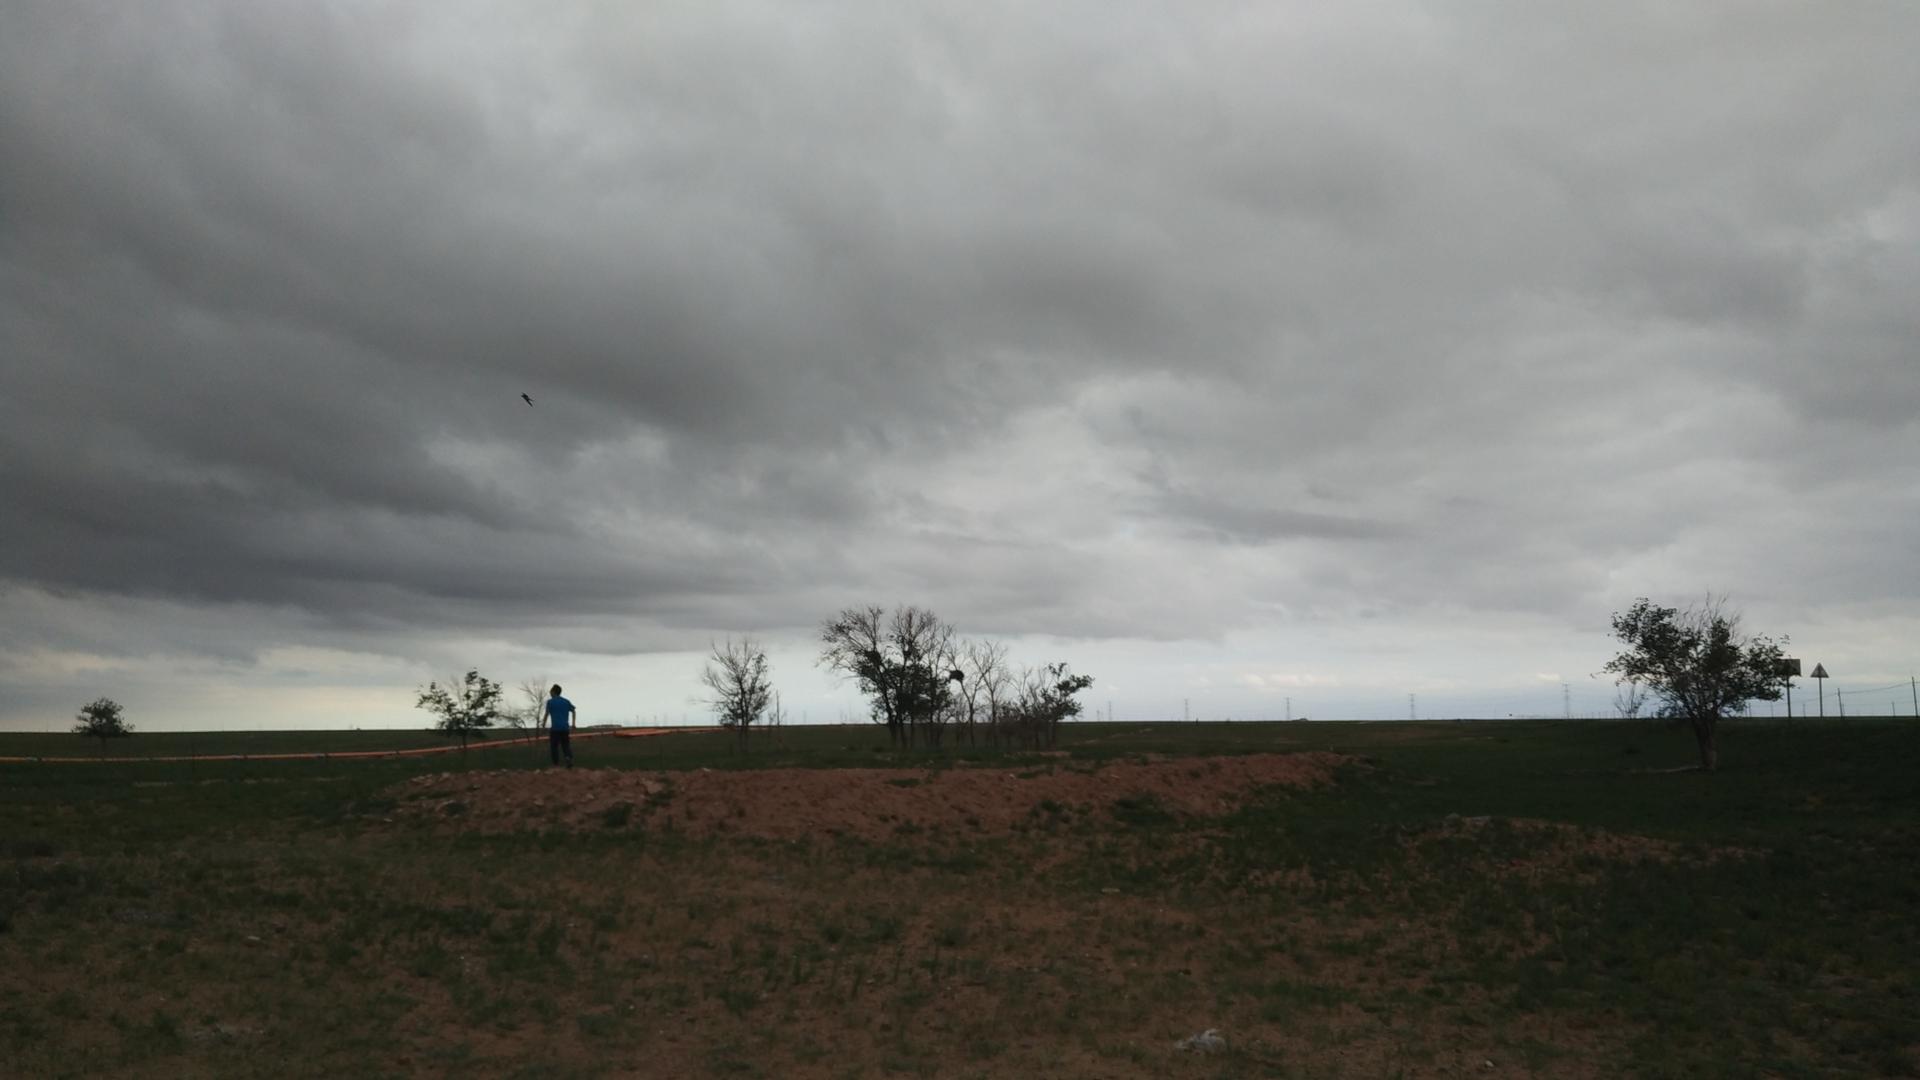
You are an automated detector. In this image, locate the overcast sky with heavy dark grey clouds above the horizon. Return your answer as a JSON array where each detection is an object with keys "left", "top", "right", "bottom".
[{"left": 0, "top": 0, "right": 1920, "bottom": 730}]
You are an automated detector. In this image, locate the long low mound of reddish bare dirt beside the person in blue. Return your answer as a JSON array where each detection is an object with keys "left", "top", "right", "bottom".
[{"left": 390, "top": 751, "right": 1357, "bottom": 838}]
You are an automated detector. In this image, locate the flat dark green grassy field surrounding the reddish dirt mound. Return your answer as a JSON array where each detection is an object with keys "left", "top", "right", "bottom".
[{"left": 0, "top": 721, "right": 1920, "bottom": 1076}]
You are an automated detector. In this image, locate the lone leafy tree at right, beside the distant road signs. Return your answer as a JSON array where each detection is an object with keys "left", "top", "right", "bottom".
[{"left": 1603, "top": 596, "right": 1786, "bottom": 773}]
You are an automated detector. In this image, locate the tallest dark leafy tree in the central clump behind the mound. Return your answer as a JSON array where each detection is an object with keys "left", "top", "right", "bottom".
[{"left": 820, "top": 607, "right": 952, "bottom": 746}]
